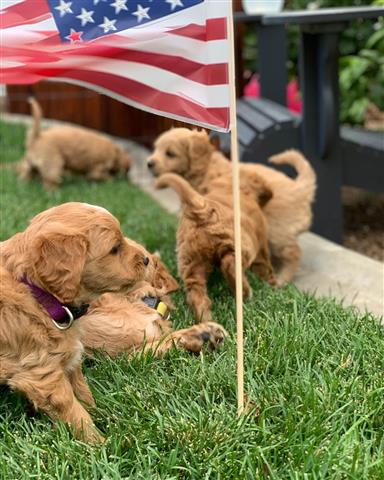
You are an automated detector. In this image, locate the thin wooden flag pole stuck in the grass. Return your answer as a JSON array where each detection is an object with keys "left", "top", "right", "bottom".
[{"left": 228, "top": 2, "right": 244, "bottom": 415}]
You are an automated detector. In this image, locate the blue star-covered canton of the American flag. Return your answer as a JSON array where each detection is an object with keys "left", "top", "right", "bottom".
[{"left": 47, "top": 0, "right": 204, "bottom": 43}]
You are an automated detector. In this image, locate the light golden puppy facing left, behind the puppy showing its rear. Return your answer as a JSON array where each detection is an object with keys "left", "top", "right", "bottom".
[{"left": 148, "top": 128, "right": 316, "bottom": 285}]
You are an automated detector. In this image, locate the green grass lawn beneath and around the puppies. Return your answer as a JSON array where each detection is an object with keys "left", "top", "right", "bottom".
[{"left": 0, "top": 119, "right": 384, "bottom": 480}]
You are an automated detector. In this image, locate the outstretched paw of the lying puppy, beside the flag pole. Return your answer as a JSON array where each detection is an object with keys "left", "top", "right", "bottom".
[{"left": 177, "top": 322, "right": 228, "bottom": 353}]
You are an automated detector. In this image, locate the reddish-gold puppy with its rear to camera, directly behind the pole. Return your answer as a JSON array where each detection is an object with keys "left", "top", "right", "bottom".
[{"left": 156, "top": 173, "right": 275, "bottom": 322}]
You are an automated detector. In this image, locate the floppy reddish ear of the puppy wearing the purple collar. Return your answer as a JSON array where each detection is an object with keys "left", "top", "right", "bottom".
[{"left": 31, "top": 232, "right": 88, "bottom": 303}]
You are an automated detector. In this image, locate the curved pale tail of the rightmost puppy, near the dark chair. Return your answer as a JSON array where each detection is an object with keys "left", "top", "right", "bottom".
[{"left": 269, "top": 150, "right": 316, "bottom": 201}]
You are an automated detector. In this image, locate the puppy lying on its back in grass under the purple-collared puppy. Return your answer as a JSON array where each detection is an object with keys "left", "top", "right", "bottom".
[{"left": 81, "top": 247, "right": 226, "bottom": 357}]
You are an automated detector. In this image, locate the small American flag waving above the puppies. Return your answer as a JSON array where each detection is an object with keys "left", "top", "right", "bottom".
[{"left": 0, "top": 0, "right": 232, "bottom": 131}]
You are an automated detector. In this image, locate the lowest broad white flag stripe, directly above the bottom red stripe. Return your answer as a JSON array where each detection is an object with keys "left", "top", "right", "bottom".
[{"left": 36, "top": 56, "right": 229, "bottom": 107}]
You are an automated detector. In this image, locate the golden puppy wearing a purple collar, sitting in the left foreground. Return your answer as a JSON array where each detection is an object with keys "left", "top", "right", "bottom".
[{"left": 0, "top": 202, "right": 222, "bottom": 442}]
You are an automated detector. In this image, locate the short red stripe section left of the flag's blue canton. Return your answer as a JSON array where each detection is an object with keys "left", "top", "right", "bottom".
[{"left": 0, "top": 0, "right": 52, "bottom": 28}]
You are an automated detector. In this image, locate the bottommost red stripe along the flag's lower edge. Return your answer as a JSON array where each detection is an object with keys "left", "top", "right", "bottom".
[{"left": 0, "top": 67, "right": 229, "bottom": 129}]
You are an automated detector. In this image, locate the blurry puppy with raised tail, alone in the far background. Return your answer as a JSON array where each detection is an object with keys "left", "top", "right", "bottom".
[{"left": 18, "top": 99, "right": 132, "bottom": 190}]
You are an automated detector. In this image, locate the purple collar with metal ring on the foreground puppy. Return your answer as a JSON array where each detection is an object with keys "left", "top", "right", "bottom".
[{"left": 21, "top": 276, "right": 89, "bottom": 330}]
